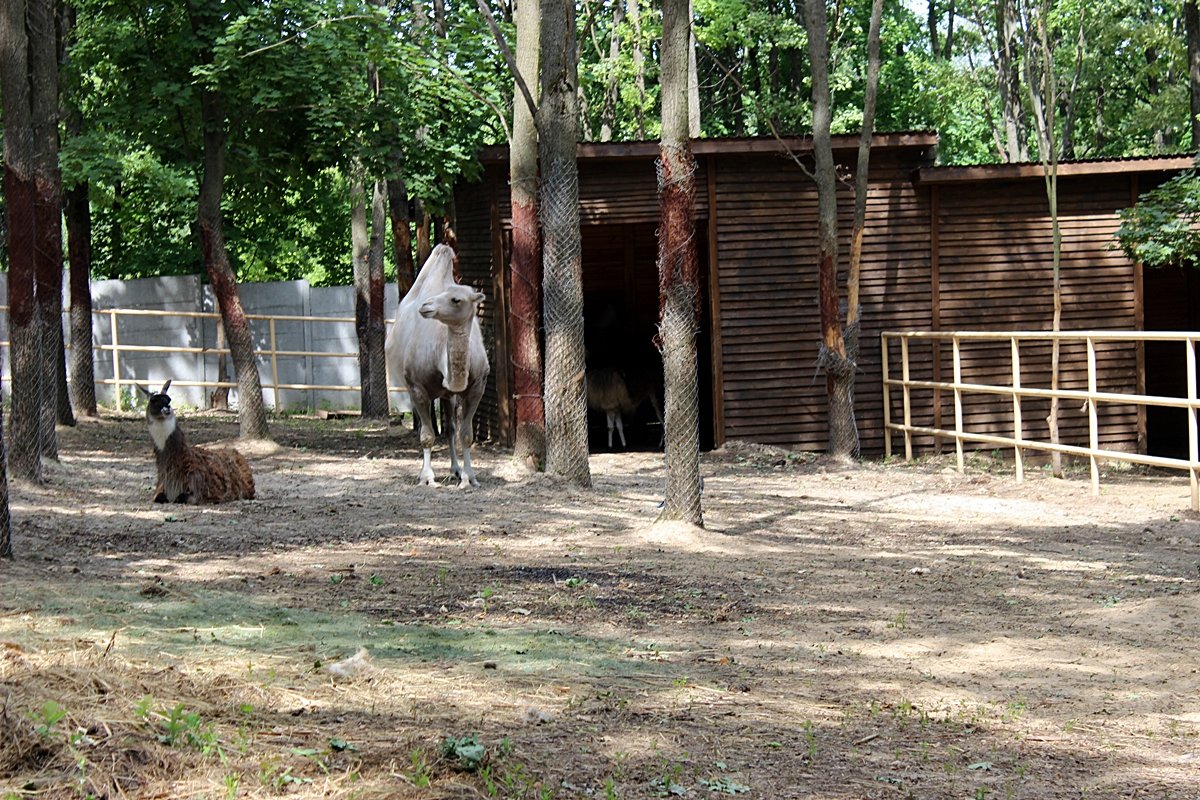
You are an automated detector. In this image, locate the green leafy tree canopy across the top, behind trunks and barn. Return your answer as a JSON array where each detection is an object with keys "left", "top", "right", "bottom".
[{"left": 0, "top": 0, "right": 1193, "bottom": 285}]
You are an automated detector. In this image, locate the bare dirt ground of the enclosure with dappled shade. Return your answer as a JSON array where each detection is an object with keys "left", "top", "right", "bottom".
[{"left": 0, "top": 414, "right": 1200, "bottom": 800}]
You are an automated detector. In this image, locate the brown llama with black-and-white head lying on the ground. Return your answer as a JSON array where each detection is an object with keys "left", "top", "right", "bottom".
[{"left": 138, "top": 380, "right": 254, "bottom": 505}]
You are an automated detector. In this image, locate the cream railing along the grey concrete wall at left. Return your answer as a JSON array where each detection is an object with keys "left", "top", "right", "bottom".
[{"left": 0, "top": 305, "right": 407, "bottom": 410}]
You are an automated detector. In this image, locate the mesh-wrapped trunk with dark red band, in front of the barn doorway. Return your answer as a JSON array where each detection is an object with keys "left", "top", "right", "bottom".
[{"left": 659, "top": 0, "right": 704, "bottom": 525}]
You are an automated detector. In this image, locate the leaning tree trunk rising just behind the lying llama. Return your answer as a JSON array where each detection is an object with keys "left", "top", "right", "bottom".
[{"left": 197, "top": 89, "right": 270, "bottom": 439}]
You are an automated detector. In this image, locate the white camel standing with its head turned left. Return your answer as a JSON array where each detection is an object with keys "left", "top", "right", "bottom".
[{"left": 385, "top": 245, "right": 490, "bottom": 488}]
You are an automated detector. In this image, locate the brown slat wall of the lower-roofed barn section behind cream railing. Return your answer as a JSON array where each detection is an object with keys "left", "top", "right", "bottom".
[{"left": 936, "top": 176, "right": 1138, "bottom": 451}]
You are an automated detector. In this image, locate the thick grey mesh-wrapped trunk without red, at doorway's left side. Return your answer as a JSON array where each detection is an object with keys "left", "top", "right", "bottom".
[{"left": 538, "top": 0, "right": 592, "bottom": 486}]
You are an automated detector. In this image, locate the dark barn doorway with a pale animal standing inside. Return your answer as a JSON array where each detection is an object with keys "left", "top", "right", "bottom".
[{"left": 582, "top": 221, "right": 713, "bottom": 452}]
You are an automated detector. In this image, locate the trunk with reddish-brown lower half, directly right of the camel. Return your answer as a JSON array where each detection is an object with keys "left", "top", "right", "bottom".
[{"left": 509, "top": 0, "right": 547, "bottom": 469}]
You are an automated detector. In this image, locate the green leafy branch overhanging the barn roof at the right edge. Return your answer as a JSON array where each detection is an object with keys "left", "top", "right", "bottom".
[{"left": 1116, "top": 167, "right": 1200, "bottom": 269}]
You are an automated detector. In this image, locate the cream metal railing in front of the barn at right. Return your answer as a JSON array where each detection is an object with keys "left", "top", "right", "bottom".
[{"left": 882, "top": 331, "right": 1200, "bottom": 511}]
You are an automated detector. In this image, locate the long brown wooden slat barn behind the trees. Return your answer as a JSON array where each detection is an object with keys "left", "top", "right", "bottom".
[{"left": 456, "top": 132, "right": 1200, "bottom": 455}]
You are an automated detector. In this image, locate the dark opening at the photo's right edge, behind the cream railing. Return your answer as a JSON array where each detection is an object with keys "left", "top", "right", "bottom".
[{"left": 1142, "top": 269, "right": 1200, "bottom": 458}]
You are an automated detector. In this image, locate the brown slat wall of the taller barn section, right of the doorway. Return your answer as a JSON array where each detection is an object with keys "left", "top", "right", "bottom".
[{"left": 710, "top": 151, "right": 930, "bottom": 453}]
